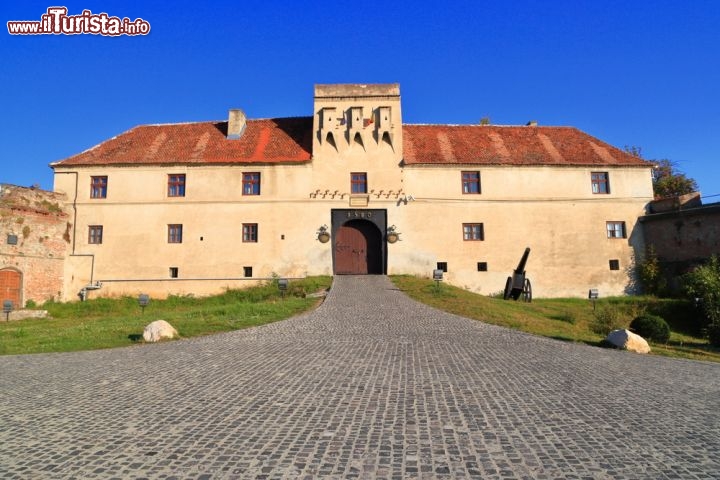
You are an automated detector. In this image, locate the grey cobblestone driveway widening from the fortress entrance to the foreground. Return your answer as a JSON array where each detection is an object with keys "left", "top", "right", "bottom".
[{"left": 0, "top": 276, "right": 720, "bottom": 479}]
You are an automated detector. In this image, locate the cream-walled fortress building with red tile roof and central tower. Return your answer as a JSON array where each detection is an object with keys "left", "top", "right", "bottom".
[{"left": 51, "top": 84, "right": 653, "bottom": 299}]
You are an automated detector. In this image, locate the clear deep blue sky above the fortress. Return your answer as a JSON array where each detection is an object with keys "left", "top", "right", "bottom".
[{"left": 0, "top": 0, "right": 720, "bottom": 199}]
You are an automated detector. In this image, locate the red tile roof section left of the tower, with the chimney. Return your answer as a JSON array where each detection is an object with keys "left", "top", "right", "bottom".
[{"left": 52, "top": 117, "right": 312, "bottom": 167}]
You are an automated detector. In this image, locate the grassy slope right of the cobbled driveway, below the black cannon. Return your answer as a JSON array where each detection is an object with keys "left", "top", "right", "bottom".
[{"left": 391, "top": 275, "right": 720, "bottom": 362}]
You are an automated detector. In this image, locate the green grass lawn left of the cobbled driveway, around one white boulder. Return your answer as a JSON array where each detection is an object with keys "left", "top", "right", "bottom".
[{"left": 0, "top": 276, "right": 332, "bottom": 355}]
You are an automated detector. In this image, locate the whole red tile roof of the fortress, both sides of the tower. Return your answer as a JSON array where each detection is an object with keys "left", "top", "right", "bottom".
[{"left": 52, "top": 117, "right": 650, "bottom": 167}]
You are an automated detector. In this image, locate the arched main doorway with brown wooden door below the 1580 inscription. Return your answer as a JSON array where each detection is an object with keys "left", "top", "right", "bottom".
[{"left": 333, "top": 219, "right": 383, "bottom": 275}]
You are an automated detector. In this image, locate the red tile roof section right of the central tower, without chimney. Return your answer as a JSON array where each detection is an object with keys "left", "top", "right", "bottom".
[{"left": 403, "top": 125, "right": 650, "bottom": 167}]
